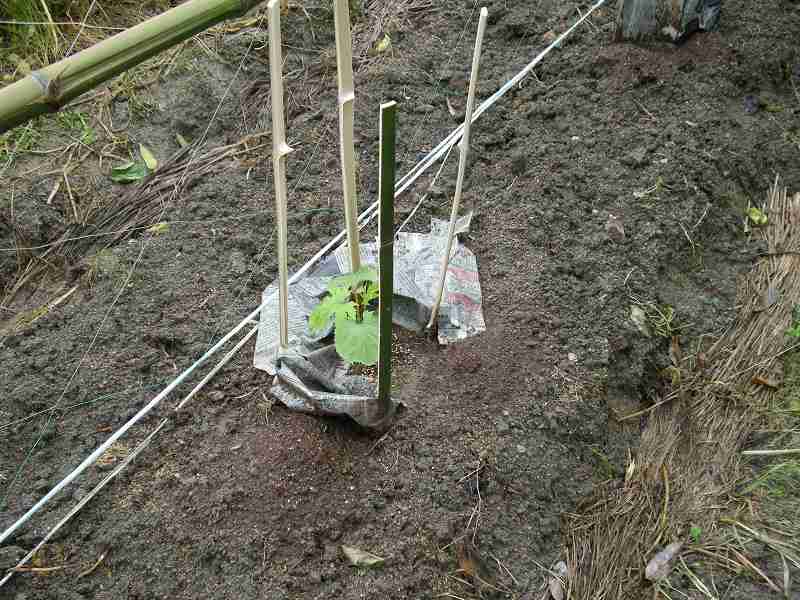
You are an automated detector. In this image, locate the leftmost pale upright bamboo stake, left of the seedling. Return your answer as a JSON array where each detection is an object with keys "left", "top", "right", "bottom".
[{"left": 267, "top": 0, "right": 292, "bottom": 351}]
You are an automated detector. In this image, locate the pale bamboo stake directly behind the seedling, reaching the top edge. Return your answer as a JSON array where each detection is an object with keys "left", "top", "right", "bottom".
[{"left": 333, "top": 0, "right": 361, "bottom": 271}]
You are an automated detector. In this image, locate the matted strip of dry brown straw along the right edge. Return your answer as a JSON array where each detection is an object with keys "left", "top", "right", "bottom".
[{"left": 567, "top": 181, "right": 800, "bottom": 600}]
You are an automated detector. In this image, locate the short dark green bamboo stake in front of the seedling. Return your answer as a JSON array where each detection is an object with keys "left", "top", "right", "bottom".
[{"left": 378, "top": 102, "right": 397, "bottom": 414}]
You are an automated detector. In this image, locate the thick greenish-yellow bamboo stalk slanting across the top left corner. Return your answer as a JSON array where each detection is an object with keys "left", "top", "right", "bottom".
[{"left": 0, "top": 0, "right": 262, "bottom": 133}]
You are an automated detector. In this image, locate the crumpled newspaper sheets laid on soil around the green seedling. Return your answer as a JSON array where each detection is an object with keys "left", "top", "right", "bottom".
[{"left": 253, "top": 213, "right": 486, "bottom": 427}]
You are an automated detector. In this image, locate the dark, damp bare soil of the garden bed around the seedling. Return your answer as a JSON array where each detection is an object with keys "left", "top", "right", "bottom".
[{"left": 0, "top": 0, "right": 800, "bottom": 600}]
